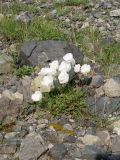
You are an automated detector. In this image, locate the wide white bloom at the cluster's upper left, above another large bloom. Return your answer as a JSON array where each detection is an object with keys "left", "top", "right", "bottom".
[{"left": 38, "top": 67, "right": 57, "bottom": 76}]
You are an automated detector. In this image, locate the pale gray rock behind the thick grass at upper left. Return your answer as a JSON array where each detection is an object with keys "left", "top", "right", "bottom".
[{"left": 16, "top": 11, "right": 32, "bottom": 24}]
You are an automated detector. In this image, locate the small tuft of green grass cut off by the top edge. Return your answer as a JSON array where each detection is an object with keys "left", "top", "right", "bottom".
[{"left": 65, "top": 0, "right": 89, "bottom": 5}]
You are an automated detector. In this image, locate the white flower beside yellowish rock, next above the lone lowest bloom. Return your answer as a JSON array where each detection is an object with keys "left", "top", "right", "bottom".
[{"left": 41, "top": 76, "right": 53, "bottom": 87}]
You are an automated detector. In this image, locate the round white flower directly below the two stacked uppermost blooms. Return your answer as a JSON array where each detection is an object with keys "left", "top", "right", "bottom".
[{"left": 58, "top": 71, "right": 69, "bottom": 84}]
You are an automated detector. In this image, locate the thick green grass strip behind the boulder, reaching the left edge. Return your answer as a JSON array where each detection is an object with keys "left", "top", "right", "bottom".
[{"left": 0, "top": 18, "right": 66, "bottom": 42}]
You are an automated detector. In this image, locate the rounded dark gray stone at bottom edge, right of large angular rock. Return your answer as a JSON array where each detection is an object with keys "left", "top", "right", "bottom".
[{"left": 49, "top": 144, "right": 67, "bottom": 160}]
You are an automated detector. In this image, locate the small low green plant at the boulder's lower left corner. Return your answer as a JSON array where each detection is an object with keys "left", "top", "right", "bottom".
[{"left": 16, "top": 65, "right": 34, "bottom": 78}]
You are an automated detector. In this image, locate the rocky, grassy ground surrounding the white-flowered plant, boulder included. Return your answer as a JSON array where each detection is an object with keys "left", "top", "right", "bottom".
[{"left": 0, "top": 0, "right": 120, "bottom": 160}]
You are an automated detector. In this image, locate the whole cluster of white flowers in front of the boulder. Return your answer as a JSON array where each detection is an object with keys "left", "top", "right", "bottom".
[{"left": 31, "top": 53, "right": 91, "bottom": 102}]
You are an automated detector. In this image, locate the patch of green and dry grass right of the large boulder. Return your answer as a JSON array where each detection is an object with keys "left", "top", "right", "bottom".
[{"left": 73, "top": 27, "right": 120, "bottom": 75}]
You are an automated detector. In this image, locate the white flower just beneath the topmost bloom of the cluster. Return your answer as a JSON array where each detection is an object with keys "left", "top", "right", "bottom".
[{"left": 59, "top": 61, "right": 71, "bottom": 72}]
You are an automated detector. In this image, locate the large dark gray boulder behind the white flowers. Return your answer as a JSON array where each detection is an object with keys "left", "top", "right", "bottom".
[{"left": 18, "top": 40, "right": 83, "bottom": 66}]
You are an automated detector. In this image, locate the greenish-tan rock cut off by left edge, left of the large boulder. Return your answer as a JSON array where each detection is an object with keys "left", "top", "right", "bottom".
[{"left": 0, "top": 54, "right": 14, "bottom": 74}]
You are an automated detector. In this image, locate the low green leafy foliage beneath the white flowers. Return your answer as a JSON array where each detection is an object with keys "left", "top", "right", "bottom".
[{"left": 32, "top": 86, "right": 86, "bottom": 119}]
